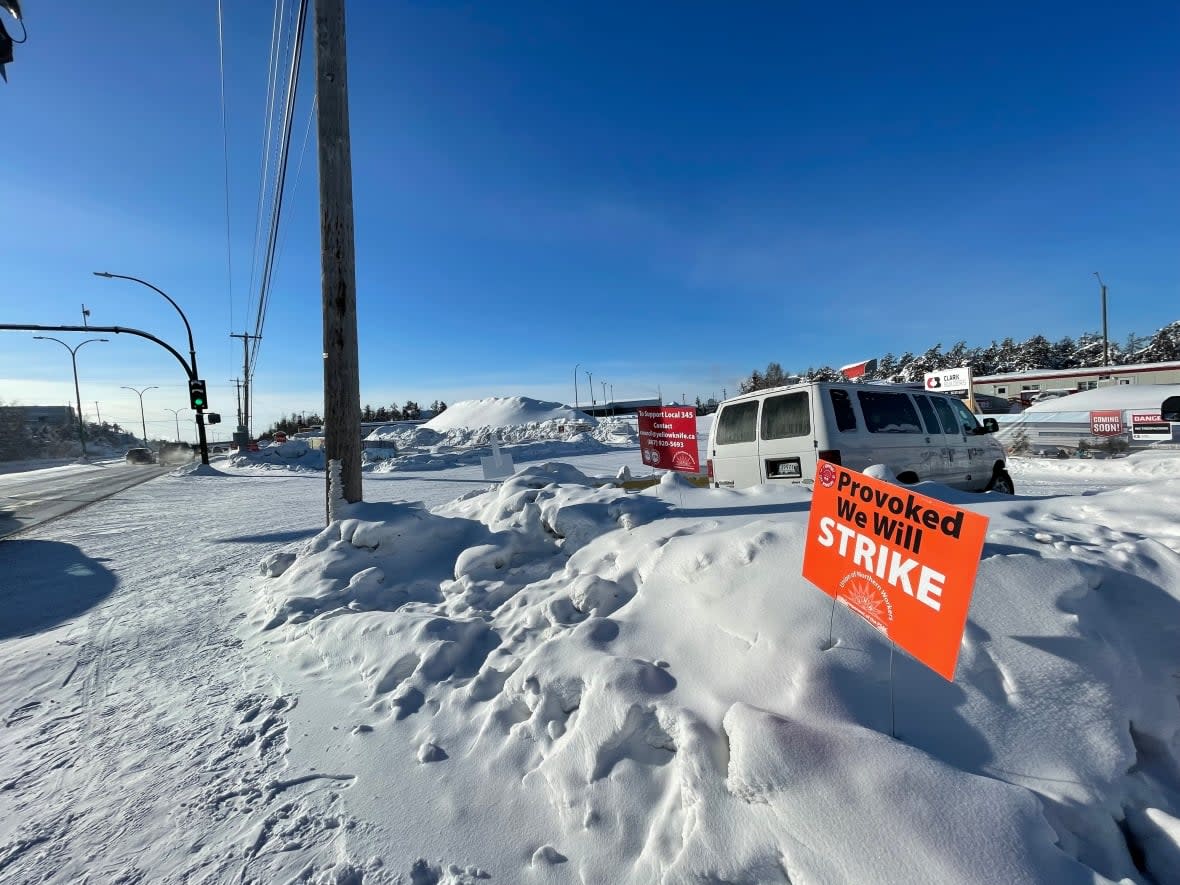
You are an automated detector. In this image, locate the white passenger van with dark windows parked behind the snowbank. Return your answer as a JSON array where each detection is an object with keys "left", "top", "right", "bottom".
[{"left": 706, "top": 381, "right": 1014, "bottom": 494}]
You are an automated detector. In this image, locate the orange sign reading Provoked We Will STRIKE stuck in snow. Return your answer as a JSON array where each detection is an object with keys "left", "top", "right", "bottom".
[{"left": 804, "top": 461, "right": 988, "bottom": 682}]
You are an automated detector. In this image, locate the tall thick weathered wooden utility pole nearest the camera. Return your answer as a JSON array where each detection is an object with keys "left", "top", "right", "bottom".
[{"left": 315, "top": 0, "right": 361, "bottom": 522}]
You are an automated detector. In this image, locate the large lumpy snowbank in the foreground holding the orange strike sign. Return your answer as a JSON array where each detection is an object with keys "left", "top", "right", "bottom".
[{"left": 246, "top": 464, "right": 1180, "bottom": 885}]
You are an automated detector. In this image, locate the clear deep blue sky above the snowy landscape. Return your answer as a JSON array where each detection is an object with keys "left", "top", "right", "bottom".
[{"left": 0, "top": 0, "right": 1180, "bottom": 441}]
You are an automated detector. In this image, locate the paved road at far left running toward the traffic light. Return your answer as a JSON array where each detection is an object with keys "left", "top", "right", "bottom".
[{"left": 0, "top": 461, "right": 172, "bottom": 538}]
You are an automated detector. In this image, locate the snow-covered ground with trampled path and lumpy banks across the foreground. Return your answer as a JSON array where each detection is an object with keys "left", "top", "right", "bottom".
[{"left": 0, "top": 403, "right": 1180, "bottom": 885}]
